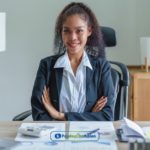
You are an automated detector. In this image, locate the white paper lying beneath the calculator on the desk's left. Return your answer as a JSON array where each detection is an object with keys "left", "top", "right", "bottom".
[{"left": 15, "top": 122, "right": 65, "bottom": 142}]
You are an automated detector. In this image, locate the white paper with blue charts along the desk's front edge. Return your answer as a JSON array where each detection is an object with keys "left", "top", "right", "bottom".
[{"left": 12, "top": 140, "right": 117, "bottom": 150}]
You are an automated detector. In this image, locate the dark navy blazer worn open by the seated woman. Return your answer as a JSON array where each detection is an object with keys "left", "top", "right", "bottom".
[{"left": 31, "top": 55, "right": 115, "bottom": 121}]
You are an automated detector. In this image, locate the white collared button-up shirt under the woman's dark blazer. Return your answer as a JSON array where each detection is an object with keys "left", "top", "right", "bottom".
[{"left": 54, "top": 51, "right": 93, "bottom": 113}]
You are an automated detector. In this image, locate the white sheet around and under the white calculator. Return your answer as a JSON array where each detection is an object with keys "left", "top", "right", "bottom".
[{"left": 15, "top": 123, "right": 65, "bottom": 142}]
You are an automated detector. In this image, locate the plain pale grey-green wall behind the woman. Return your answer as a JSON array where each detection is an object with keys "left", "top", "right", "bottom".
[{"left": 0, "top": 0, "right": 150, "bottom": 120}]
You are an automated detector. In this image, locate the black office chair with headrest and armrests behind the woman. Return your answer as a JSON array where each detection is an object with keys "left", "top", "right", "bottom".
[{"left": 13, "top": 26, "right": 129, "bottom": 121}]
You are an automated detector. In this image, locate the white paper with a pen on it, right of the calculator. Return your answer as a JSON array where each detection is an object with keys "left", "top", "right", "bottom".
[{"left": 69, "top": 121, "right": 116, "bottom": 140}]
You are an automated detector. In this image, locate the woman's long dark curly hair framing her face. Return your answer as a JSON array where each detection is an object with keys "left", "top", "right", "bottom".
[{"left": 54, "top": 2, "right": 105, "bottom": 57}]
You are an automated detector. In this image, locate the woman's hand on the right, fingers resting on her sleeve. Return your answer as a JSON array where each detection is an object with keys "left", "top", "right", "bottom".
[{"left": 92, "top": 96, "right": 107, "bottom": 112}]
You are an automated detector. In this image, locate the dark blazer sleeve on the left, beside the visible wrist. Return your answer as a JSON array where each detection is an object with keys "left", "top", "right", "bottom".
[{"left": 31, "top": 59, "right": 53, "bottom": 121}]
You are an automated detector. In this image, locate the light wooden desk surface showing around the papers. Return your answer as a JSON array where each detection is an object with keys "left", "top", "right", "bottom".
[{"left": 0, "top": 121, "right": 150, "bottom": 150}]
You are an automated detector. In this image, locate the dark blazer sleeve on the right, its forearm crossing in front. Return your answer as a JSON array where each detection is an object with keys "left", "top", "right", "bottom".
[{"left": 65, "top": 61, "right": 115, "bottom": 121}]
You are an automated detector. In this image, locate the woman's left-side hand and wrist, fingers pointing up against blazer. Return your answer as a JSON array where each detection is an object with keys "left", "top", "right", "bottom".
[{"left": 42, "top": 87, "right": 65, "bottom": 120}]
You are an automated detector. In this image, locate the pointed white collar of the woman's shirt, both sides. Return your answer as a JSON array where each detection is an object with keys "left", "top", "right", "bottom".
[{"left": 54, "top": 51, "right": 93, "bottom": 70}]
